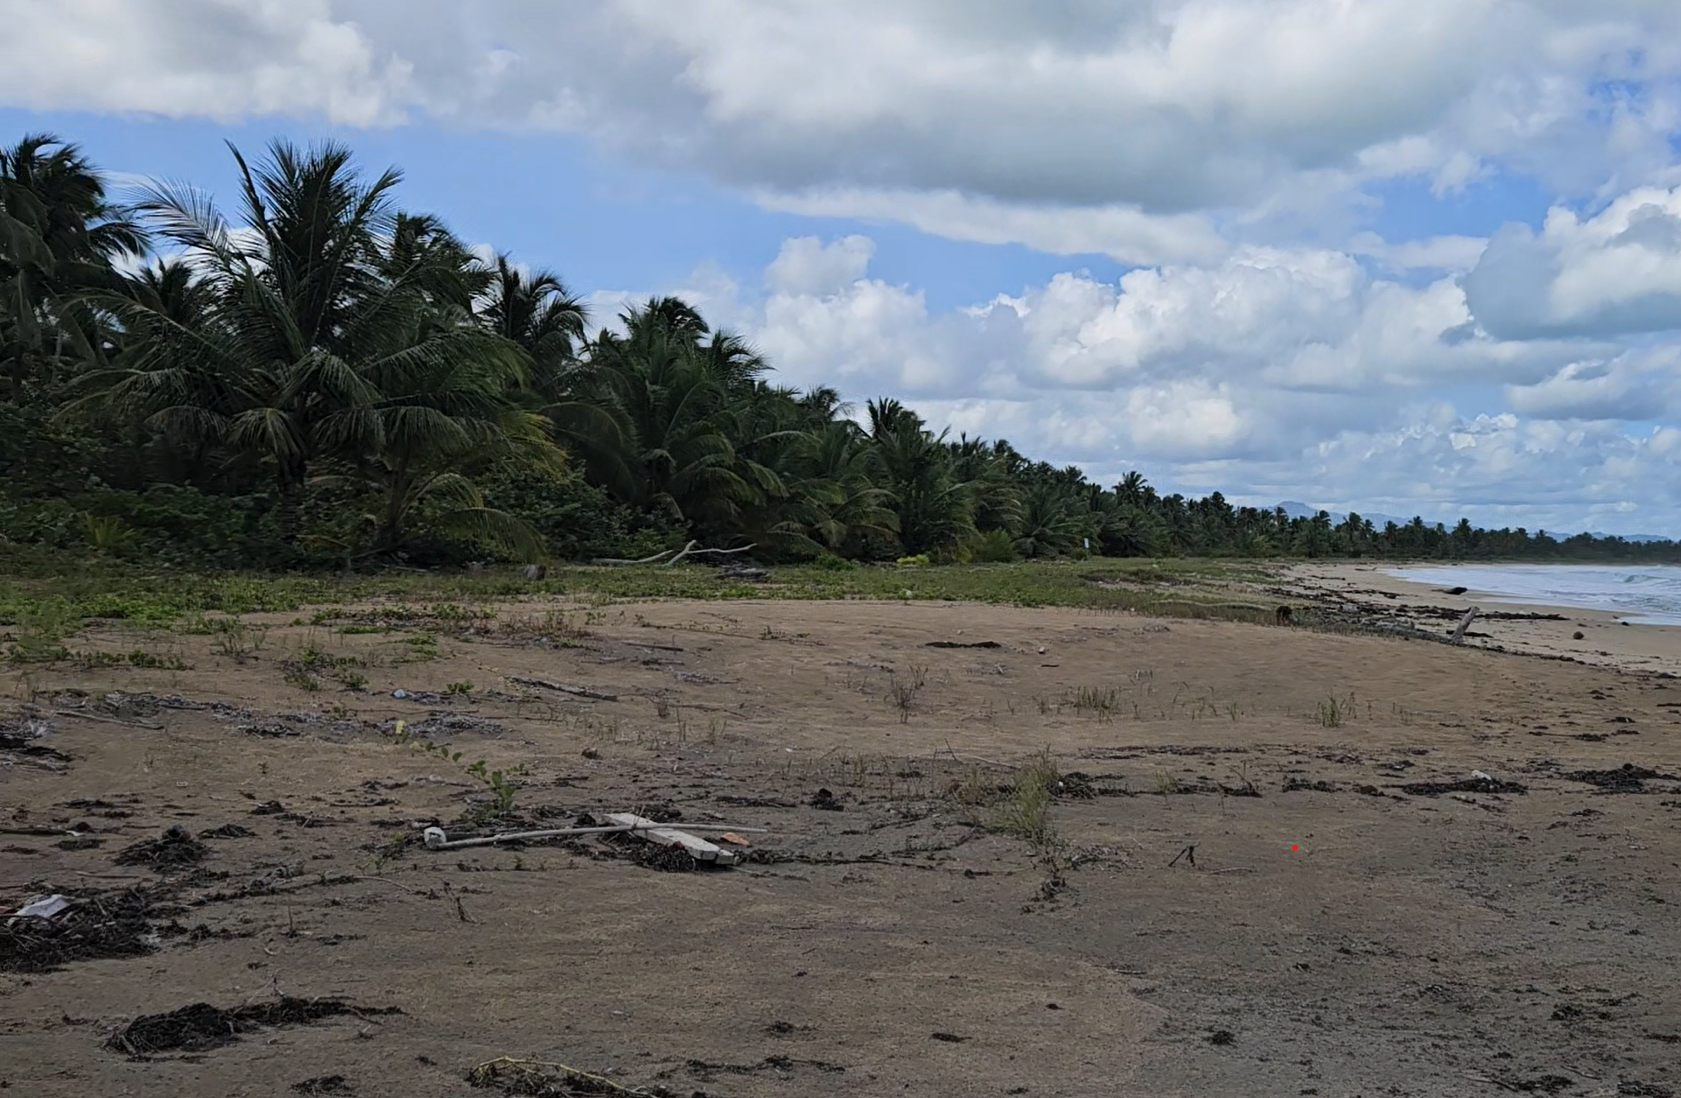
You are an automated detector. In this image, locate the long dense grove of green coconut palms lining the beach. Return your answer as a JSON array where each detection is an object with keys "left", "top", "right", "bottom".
[{"left": 0, "top": 136, "right": 1676, "bottom": 567}]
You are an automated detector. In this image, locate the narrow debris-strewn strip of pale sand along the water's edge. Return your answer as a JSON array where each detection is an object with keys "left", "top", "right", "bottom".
[{"left": 1273, "top": 562, "right": 1681, "bottom": 676}]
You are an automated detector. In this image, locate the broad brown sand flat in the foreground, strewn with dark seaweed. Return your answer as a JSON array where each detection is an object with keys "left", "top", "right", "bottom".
[{"left": 0, "top": 595, "right": 1681, "bottom": 1098}]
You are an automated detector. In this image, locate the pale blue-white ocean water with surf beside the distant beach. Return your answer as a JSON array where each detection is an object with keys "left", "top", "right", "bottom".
[{"left": 1390, "top": 565, "right": 1681, "bottom": 626}]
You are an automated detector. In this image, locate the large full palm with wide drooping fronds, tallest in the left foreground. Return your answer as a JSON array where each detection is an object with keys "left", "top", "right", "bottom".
[{"left": 89, "top": 141, "right": 530, "bottom": 548}]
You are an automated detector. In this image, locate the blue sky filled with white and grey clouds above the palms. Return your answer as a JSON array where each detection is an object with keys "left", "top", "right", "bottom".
[{"left": 0, "top": 0, "right": 1681, "bottom": 535}]
